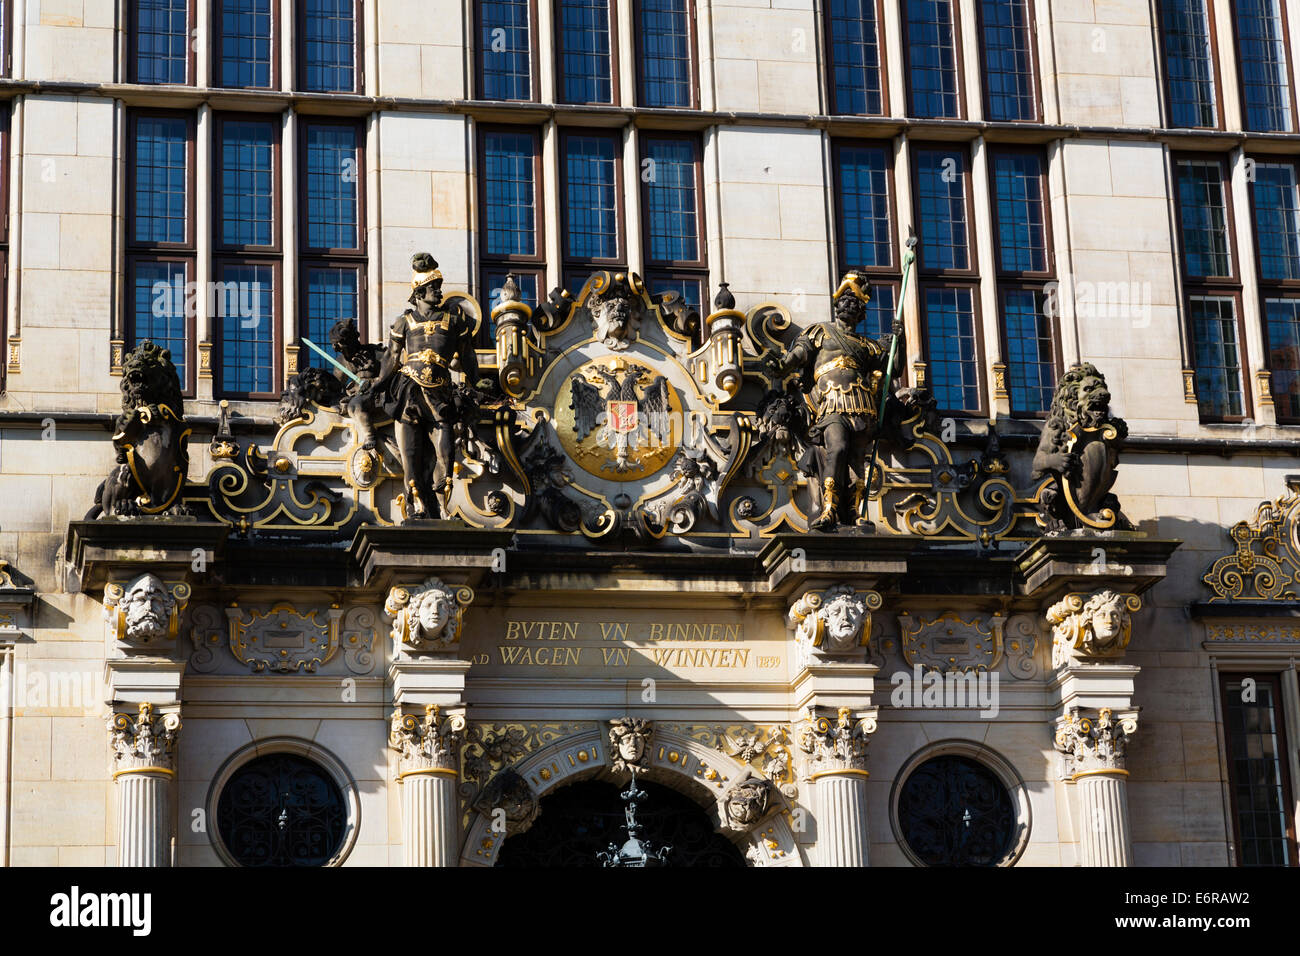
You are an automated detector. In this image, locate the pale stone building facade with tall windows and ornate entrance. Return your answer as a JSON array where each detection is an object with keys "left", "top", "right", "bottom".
[{"left": 0, "top": 0, "right": 1300, "bottom": 866}]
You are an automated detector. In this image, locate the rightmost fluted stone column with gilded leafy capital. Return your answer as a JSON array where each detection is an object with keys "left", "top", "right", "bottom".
[{"left": 1056, "top": 708, "right": 1138, "bottom": 866}]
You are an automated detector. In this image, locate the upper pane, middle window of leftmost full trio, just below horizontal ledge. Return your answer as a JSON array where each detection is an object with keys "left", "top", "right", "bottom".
[{"left": 218, "top": 120, "right": 276, "bottom": 246}]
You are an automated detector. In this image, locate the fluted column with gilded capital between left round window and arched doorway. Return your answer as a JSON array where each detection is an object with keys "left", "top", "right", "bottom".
[{"left": 389, "top": 704, "right": 465, "bottom": 866}]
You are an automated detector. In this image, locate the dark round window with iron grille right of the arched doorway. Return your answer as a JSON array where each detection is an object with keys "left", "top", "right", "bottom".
[{"left": 896, "top": 753, "right": 1028, "bottom": 866}]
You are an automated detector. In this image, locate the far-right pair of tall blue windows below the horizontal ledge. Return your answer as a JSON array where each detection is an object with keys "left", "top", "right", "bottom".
[{"left": 1174, "top": 153, "right": 1300, "bottom": 424}]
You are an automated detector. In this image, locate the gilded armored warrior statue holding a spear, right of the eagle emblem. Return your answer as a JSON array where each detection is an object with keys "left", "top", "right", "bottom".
[{"left": 766, "top": 271, "right": 902, "bottom": 531}]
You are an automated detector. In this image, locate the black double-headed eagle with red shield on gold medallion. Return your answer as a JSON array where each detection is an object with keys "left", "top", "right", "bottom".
[{"left": 569, "top": 359, "right": 672, "bottom": 472}]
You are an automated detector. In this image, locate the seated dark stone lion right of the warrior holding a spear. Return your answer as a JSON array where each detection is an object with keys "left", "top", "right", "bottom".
[{"left": 1034, "top": 362, "right": 1132, "bottom": 532}]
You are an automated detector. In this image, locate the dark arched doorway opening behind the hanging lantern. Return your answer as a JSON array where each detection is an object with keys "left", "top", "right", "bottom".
[{"left": 497, "top": 779, "right": 745, "bottom": 868}]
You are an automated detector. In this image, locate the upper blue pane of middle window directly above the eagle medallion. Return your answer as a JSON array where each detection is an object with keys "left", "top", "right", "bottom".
[{"left": 564, "top": 137, "right": 619, "bottom": 259}]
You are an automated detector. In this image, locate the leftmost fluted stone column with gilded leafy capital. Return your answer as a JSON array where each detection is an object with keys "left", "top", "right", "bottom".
[{"left": 108, "top": 704, "right": 181, "bottom": 866}]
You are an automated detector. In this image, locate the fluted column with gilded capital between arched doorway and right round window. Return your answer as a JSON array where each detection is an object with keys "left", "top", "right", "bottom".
[{"left": 797, "top": 708, "right": 876, "bottom": 866}]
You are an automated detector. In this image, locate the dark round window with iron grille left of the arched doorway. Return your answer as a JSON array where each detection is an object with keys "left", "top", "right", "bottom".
[{"left": 217, "top": 753, "right": 348, "bottom": 866}]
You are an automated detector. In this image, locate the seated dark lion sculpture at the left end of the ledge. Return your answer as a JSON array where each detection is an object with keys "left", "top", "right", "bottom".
[{"left": 86, "top": 341, "right": 190, "bottom": 518}]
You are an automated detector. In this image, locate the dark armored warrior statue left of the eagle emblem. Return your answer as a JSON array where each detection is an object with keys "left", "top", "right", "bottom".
[{"left": 371, "top": 252, "right": 478, "bottom": 518}]
